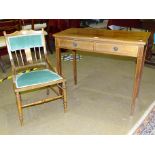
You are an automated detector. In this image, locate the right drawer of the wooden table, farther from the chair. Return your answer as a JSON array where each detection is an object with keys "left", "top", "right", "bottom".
[{"left": 94, "top": 43, "right": 138, "bottom": 57}]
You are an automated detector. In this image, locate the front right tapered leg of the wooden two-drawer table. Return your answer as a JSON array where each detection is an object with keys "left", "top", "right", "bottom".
[{"left": 131, "top": 47, "right": 145, "bottom": 115}]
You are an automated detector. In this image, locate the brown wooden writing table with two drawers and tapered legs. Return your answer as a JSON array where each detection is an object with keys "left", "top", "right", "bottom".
[{"left": 53, "top": 28, "right": 150, "bottom": 114}]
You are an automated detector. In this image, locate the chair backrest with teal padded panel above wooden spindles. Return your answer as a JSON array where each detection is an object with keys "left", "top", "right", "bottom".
[{"left": 4, "top": 29, "right": 47, "bottom": 67}]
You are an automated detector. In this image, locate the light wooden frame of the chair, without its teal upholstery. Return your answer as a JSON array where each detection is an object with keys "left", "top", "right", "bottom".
[{"left": 4, "top": 29, "right": 67, "bottom": 125}]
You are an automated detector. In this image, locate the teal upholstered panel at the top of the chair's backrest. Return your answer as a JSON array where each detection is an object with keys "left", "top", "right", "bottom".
[{"left": 9, "top": 34, "right": 43, "bottom": 51}]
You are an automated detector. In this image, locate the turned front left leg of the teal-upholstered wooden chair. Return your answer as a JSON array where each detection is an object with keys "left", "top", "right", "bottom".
[{"left": 16, "top": 92, "right": 23, "bottom": 126}]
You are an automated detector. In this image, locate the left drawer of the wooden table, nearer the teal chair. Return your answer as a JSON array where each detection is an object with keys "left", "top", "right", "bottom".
[{"left": 58, "top": 39, "right": 94, "bottom": 51}]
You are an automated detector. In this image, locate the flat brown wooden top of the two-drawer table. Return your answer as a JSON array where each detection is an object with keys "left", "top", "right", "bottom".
[{"left": 53, "top": 28, "right": 150, "bottom": 45}]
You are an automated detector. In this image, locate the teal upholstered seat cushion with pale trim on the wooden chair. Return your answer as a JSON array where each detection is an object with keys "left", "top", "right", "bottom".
[{"left": 16, "top": 69, "right": 62, "bottom": 88}]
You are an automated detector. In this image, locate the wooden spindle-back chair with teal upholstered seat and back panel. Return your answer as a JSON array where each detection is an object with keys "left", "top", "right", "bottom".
[{"left": 4, "top": 29, "right": 67, "bottom": 125}]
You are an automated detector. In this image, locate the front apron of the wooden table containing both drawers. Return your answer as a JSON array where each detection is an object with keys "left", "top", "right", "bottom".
[{"left": 56, "top": 38, "right": 141, "bottom": 57}]
